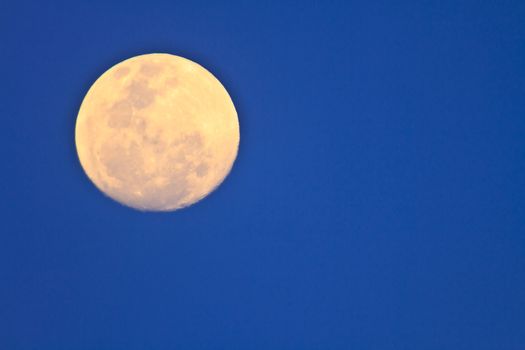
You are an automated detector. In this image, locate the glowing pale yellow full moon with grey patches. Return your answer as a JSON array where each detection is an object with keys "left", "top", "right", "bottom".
[{"left": 75, "top": 54, "right": 239, "bottom": 211}]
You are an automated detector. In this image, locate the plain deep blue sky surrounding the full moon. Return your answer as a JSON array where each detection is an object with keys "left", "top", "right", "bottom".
[{"left": 0, "top": 0, "right": 525, "bottom": 350}]
